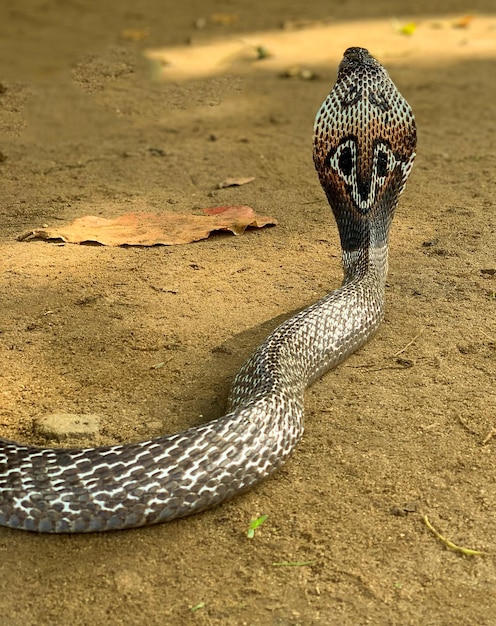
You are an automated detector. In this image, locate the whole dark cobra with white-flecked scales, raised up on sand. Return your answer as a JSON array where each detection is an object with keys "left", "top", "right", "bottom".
[{"left": 0, "top": 48, "right": 416, "bottom": 533}]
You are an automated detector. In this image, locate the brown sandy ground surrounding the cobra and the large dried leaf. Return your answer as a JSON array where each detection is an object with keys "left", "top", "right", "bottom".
[{"left": 0, "top": 0, "right": 496, "bottom": 626}]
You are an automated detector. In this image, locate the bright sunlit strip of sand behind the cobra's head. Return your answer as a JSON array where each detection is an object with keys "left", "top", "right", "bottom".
[{"left": 145, "top": 15, "right": 496, "bottom": 80}]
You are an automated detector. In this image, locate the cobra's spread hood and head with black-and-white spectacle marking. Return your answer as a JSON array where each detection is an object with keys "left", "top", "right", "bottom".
[{"left": 313, "top": 48, "right": 417, "bottom": 264}]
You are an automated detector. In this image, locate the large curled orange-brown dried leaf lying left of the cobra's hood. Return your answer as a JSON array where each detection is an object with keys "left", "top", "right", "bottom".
[{"left": 18, "top": 206, "right": 277, "bottom": 246}]
